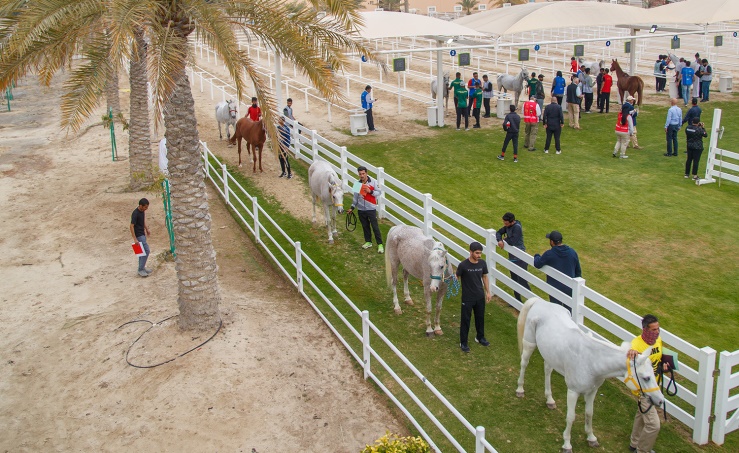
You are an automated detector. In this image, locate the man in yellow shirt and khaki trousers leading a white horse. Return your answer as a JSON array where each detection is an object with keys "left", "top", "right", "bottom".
[{"left": 628, "top": 315, "right": 667, "bottom": 453}]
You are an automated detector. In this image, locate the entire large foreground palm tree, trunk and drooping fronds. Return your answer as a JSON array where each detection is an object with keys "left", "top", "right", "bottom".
[{"left": 0, "top": 0, "right": 372, "bottom": 329}]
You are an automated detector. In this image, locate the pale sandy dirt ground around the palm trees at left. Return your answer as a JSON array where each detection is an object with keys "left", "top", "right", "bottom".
[{"left": 0, "top": 74, "right": 407, "bottom": 453}]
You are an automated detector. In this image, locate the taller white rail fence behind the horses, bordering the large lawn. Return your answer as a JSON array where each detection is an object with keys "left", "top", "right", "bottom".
[{"left": 192, "top": 65, "right": 737, "bottom": 445}]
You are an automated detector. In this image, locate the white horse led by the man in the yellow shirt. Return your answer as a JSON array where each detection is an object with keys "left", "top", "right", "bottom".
[{"left": 516, "top": 297, "right": 664, "bottom": 453}]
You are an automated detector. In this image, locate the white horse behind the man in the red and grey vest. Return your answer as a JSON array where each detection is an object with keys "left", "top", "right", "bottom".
[{"left": 308, "top": 160, "right": 344, "bottom": 244}]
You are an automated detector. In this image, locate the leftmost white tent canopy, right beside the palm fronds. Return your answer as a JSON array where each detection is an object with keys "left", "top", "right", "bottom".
[{"left": 358, "top": 11, "right": 484, "bottom": 39}]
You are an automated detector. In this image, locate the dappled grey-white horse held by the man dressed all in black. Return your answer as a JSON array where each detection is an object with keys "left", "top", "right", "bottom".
[{"left": 385, "top": 225, "right": 454, "bottom": 337}]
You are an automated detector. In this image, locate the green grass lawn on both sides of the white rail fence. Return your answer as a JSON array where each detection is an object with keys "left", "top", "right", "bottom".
[{"left": 212, "top": 106, "right": 739, "bottom": 452}]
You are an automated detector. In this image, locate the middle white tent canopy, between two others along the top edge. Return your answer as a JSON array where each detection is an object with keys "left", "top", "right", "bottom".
[{"left": 454, "top": 0, "right": 644, "bottom": 36}]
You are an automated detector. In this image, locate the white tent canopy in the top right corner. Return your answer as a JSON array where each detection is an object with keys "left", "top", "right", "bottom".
[{"left": 647, "top": 0, "right": 739, "bottom": 25}]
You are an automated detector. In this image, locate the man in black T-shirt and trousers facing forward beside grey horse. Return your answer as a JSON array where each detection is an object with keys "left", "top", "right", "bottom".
[{"left": 457, "top": 242, "right": 492, "bottom": 352}]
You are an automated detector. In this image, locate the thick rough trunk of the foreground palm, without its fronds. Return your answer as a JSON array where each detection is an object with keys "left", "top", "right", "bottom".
[{"left": 164, "top": 66, "right": 221, "bottom": 330}]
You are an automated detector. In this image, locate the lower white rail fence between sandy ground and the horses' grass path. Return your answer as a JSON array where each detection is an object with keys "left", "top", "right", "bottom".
[{"left": 200, "top": 142, "right": 497, "bottom": 453}]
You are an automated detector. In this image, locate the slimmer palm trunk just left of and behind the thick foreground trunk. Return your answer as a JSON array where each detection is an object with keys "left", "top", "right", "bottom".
[{"left": 128, "top": 28, "right": 154, "bottom": 190}]
